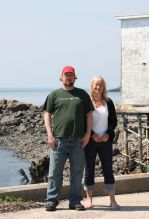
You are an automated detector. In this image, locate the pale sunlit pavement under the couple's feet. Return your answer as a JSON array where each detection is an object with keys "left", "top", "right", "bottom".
[{"left": 0, "top": 192, "right": 149, "bottom": 219}]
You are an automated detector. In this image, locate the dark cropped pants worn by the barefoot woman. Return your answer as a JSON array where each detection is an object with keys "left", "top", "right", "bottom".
[{"left": 84, "top": 139, "right": 115, "bottom": 189}]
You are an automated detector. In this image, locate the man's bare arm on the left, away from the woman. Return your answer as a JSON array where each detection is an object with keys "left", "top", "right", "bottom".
[{"left": 44, "top": 112, "right": 56, "bottom": 149}]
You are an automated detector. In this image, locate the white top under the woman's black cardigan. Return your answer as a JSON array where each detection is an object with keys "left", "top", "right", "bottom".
[{"left": 92, "top": 103, "right": 108, "bottom": 137}]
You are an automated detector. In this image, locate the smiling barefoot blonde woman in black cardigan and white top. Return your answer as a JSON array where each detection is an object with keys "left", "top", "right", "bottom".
[{"left": 84, "top": 76, "right": 120, "bottom": 209}]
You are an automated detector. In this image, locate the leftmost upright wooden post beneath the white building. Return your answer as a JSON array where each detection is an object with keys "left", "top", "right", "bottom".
[{"left": 123, "top": 115, "right": 129, "bottom": 168}]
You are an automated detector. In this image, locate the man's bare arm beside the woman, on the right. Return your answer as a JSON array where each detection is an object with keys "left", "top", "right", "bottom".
[{"left": 81, "top": 112, "right": 93, "bottom": 148}]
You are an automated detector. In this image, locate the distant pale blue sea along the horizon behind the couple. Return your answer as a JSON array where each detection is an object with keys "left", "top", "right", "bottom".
[{"left": 0, "top": 89, "right": 120, "bottom": 106}]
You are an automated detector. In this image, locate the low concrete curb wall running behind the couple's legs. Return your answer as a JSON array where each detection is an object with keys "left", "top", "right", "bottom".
[{"left": 0, "top": 173, "right": 149, "bottom": 201}]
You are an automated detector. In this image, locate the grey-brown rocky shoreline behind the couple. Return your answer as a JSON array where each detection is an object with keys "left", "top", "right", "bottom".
[{"left": 0, "top": 99, "right": 147, "bottom": 183}]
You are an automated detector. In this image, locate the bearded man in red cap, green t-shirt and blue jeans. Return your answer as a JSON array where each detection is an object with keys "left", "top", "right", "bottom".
[{"left": 43, "top": 66, "right": 94, "bottom": 211}]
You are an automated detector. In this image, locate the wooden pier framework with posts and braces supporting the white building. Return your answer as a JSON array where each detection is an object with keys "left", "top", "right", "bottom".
[{"left": 117, "top": 112, "right": 149, "bottom": 172}]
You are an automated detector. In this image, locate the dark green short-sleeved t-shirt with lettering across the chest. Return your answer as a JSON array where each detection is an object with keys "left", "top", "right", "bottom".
[{"left": 43, "top": 88, "right": 94, "bottom": 137}]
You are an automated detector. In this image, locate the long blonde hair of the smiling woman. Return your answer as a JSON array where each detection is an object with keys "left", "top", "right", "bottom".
[{"left": 90, "top": 75, "right": 107, "bottom": 100}]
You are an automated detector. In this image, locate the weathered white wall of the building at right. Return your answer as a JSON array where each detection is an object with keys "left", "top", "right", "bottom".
[{"left": 121, "top": 17, "right": 149, "bottom": 105}]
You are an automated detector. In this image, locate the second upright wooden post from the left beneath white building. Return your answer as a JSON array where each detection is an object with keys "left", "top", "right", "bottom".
[{"left": 137, "top": 113, "right": 143, "bottom": 170}]
